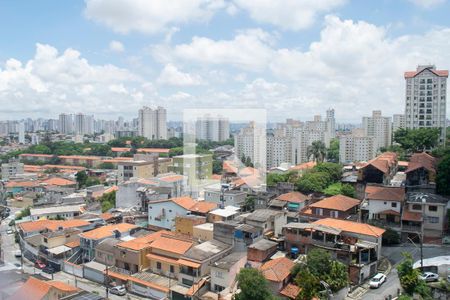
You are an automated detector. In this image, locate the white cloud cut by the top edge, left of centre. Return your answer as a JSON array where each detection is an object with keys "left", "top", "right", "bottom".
[{"left": 85, "top": 0, "right": 225, "bottom": 33}]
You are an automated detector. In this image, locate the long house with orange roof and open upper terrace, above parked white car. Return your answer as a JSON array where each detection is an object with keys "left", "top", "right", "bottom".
[{"left": 284, "top": 218, "right": 385, "bottom": 284}]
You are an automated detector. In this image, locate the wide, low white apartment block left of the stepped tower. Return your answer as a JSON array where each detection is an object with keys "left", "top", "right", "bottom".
[{"left": 339, "top": 134, "right": 376, "bottom": 163}]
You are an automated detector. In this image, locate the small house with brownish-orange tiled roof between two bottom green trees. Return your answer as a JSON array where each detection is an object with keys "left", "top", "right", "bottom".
[{"left": 260, "top": 257, "right": 295, "bottom": 295}]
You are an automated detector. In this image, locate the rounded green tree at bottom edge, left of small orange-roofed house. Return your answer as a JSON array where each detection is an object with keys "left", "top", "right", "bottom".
[{"left": 234, "top": 268, "right": 275, "bottom": 300}]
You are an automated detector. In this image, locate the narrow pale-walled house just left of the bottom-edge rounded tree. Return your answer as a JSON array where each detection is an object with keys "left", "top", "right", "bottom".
[{"left": 210, "top": 252, "right": 247, "bottom": 293}]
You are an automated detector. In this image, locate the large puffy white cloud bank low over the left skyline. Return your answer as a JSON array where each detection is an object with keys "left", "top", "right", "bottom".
[{"left": 0, "top": 44, "right": 151, "bottom": 118}]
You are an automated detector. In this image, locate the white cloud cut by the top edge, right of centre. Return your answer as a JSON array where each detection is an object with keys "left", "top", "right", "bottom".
[{"left": 234, "top": 0, "right": 346, "bottom": 30}]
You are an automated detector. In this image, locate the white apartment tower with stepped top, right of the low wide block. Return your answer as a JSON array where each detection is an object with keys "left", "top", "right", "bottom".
[{"left": 362, "top": 110, "right": 392, "bottom": 151}]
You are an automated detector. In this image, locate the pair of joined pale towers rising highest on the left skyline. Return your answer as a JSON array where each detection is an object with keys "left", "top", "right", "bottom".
[{"left": 138, "top": 106, "right": 167, "bottom": 140}]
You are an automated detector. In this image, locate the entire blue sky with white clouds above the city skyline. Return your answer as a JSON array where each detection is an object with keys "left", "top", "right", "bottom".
[{"left": 0, "top": 0, "right": 450, "bottom": 123}]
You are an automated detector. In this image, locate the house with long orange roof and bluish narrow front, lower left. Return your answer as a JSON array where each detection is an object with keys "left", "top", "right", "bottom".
[{"left": 80, "top": 223, "right": 139, "bottom": 262}]
